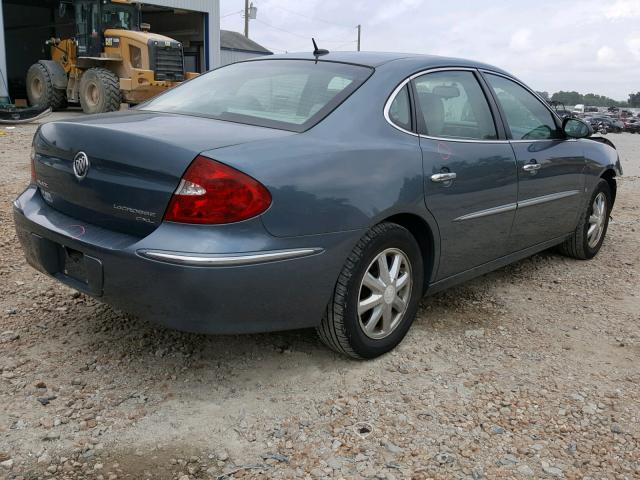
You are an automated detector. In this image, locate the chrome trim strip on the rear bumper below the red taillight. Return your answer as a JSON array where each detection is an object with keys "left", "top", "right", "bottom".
[{"left": 138, "top": 248, "right": 324, "bottom": 267}]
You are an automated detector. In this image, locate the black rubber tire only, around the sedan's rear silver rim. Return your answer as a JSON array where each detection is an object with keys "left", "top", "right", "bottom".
[{"left": 317, "top": 223, "right": 424, "bottom": 359}]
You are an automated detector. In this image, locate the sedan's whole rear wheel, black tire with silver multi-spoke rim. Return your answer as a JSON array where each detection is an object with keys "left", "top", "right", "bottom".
[{"left": 317, "top": 223, "right": 424, "bottom": 358}]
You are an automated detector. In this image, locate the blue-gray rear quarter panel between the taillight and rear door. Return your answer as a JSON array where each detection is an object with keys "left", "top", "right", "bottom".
[{"left": 205, "top": 68, "right": 427, "bottom": 237}]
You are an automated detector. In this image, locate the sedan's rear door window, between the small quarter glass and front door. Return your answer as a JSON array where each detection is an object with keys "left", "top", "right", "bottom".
[{"left": 414, "top": 71, "right": 498, "bottom": 140}]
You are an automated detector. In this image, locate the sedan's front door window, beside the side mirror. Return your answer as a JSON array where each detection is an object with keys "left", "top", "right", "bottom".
[{"left": 486, "top": 74, "right": 559, "bottom": 140}]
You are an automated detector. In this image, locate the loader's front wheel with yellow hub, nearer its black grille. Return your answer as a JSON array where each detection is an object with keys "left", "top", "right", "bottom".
[{"left": 80, "top": 67, "right": 122, "bottom": 113}]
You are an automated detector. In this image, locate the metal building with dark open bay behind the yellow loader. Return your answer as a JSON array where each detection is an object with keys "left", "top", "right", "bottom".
[{"left": 0, "top": 0, "right": 220, "bottom": 98}]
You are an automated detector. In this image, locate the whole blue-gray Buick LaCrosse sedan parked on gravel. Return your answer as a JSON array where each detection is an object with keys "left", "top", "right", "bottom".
[{"left": 14, "top": 53, "right": 622, "bottom": 358}]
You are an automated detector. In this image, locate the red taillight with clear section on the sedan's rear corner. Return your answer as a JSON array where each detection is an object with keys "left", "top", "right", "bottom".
[{"left": 164, "top": 155, "right": 271, "bottom": 224}]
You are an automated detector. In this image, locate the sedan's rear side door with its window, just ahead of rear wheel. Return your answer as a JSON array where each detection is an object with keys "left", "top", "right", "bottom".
[{"left": 413, "top": 69, "right": 517, "bottom": 280}]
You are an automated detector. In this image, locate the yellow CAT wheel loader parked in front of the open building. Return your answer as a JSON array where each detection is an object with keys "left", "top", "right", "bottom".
[{"left": 26, "top": 0, "right": 197, "bottom": 113}]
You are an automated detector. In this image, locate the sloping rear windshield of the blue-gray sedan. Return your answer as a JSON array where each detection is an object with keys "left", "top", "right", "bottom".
[{"left": 139, "top": 60, "right": 373, "bottom": 131}]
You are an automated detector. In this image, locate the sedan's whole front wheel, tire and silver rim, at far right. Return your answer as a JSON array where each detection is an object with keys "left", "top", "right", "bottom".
[{"left": 560, "top": 179, "right": 612, "bottom": 260}]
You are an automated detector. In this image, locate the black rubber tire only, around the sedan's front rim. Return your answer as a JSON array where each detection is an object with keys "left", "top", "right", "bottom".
[{"left": 559, "top": 179, "right": 612, "bottom": 260}]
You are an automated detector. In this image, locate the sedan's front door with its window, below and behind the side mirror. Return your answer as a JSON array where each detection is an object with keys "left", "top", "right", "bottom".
[{"left": 484, "top": 72, "right": 585, "bottom": 252}]
